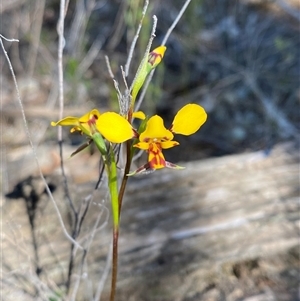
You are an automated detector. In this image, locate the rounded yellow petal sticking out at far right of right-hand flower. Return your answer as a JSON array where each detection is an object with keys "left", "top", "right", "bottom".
[{"left": 170, "top": 104, "right": 207, "bottom": 135}]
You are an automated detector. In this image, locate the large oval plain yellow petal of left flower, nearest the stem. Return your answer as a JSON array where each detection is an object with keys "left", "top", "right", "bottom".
[{"left": 96, "top": 112, "right": 134, "bottom": 143}]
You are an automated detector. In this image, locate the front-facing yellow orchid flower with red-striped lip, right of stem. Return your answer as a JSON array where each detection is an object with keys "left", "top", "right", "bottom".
[{"left": 129, "top": 104, "right": 207, "bottom": 175}]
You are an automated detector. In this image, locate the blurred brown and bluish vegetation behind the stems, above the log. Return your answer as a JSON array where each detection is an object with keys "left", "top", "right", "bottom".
[{"left": 1, "top": 0, "right": 300, "bottom": 161}]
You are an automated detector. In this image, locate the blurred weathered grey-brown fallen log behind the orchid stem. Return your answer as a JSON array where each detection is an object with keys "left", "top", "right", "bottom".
[{"left": 3, "top": 145, "right": 300, "bottom": 301}]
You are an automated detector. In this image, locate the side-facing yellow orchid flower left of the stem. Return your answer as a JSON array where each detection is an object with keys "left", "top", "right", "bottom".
[{"left": 51, "top": 109, "right": 136, "bottom": 143}]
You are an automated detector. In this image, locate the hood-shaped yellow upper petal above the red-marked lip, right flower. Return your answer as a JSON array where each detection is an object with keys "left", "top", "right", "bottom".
[{"left": 140, "top": 115, "right": 174, "bottom": 142}]
